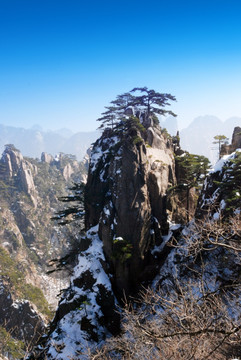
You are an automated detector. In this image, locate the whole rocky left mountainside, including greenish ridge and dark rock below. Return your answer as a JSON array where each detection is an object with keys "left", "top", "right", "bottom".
[{"left": 0, "top": 145, "right": 85, "bottom": 358}]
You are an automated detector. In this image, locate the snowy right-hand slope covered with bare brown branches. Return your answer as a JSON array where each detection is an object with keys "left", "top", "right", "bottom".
[{"left": 90, "top": 128, "right": 241, "bottom": 360}]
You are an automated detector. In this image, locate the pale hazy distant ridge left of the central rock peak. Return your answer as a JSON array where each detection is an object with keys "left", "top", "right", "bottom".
[{"left": 0, "top": 124, "right": 99, "bottom": 160}]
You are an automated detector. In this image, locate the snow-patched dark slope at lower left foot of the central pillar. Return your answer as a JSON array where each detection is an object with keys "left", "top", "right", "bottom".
[{"left": 40, "top": 226, "right": 118, "bottom": 360}]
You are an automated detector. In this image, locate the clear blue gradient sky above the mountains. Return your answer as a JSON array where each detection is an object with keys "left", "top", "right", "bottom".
[{"left": 0, "top": 0, "right": 241, "bottom": 131}]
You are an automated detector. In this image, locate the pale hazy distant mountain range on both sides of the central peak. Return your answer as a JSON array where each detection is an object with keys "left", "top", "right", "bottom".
[{"left": 0, "top": 115, "right": 241, "bottom": 163}]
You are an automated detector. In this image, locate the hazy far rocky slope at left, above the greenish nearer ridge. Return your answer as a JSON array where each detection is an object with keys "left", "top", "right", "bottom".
[{"left": 0, "top": 145, "right": 85, "bottom": 305}]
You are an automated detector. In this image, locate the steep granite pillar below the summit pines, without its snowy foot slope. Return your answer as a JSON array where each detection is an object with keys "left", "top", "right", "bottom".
[{"left": 86, "top": 122, "right": 176, "bottom": 295}]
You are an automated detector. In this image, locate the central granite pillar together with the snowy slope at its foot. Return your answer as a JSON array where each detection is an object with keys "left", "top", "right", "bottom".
[{"left": 29, "top": 117, "right": 196, "bottom": 360}]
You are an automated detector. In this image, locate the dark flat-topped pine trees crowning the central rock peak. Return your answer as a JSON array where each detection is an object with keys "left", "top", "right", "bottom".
[{"left": 97, "top": 87, "right": 176, "bottom": 130}]
